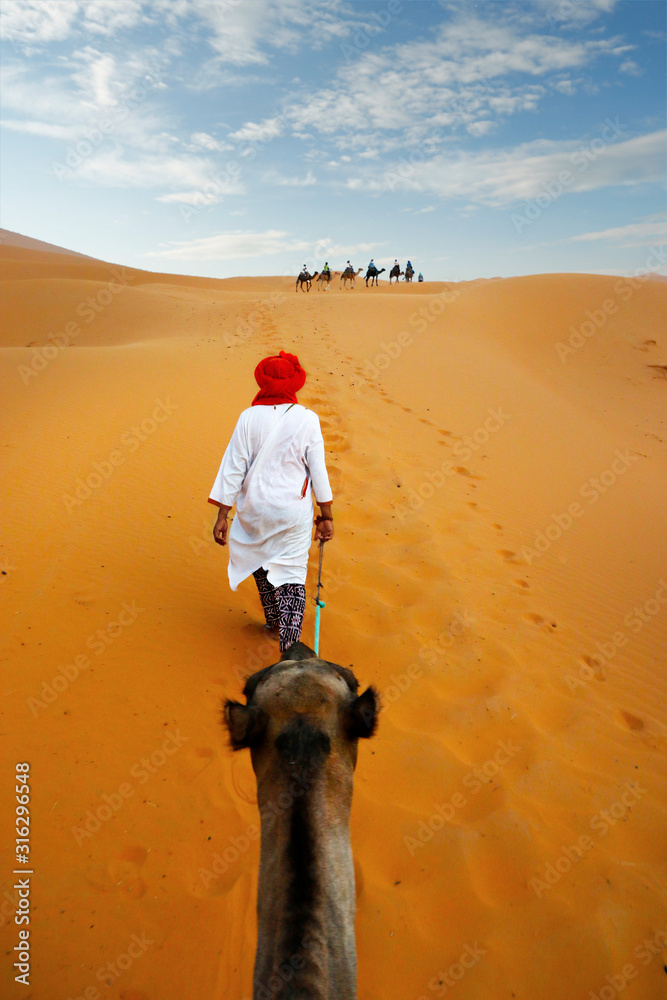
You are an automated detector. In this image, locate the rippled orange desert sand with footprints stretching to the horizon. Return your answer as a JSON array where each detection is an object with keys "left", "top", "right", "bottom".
[{"left": 0, "top": 236, "right": 667, "bottom": 1000}]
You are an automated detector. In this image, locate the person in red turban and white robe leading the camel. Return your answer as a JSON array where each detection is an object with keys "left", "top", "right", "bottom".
[{"left": 209, "top": 351, "right": 333, "bottom": 650}]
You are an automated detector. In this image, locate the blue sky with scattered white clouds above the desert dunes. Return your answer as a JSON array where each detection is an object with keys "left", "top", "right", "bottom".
[{"left": 0, "top": 0, "right": 667, "bottom": 281}]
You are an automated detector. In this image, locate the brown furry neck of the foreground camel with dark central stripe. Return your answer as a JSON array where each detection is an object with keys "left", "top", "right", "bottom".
[{"left": 253, "top": 772, "right": 356, "bottom": 1000}]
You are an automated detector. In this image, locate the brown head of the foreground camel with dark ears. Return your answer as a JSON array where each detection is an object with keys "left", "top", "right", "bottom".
[{"left": 224, "top": 642, "right": 379, "bottom": 805}]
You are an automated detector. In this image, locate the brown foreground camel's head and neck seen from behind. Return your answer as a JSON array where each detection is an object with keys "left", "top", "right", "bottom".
[{"left": 225, "top": 642, "right": 378, "bottom": 1000}]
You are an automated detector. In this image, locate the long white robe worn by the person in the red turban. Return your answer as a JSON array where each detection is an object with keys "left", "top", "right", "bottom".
[{"left": 210, "top": 403, "right": 332, "bottom": 590}]
